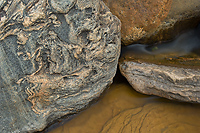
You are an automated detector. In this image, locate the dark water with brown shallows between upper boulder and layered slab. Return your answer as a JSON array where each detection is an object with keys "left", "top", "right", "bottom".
[{"left": 120, "top": 24, "right": 200, "bottom": 70}]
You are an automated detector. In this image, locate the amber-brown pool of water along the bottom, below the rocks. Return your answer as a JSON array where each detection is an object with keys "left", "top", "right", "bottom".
[{"left": 45, "top": 74, "right": 200, "bottom": 133}]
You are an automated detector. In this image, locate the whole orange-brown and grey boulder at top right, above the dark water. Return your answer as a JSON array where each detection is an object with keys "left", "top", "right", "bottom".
[{"left": 103, "top": 0, "right": 200, "bottom": 45}]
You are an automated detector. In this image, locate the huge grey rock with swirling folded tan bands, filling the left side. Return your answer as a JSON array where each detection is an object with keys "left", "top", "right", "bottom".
[{"left": 0, "top": 0, "right": 121, "bottom": 133}]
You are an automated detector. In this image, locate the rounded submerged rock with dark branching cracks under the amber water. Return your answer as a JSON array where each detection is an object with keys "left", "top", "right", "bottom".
[{"left": 101, "top": 103, "right": 200, "bottom": 133}]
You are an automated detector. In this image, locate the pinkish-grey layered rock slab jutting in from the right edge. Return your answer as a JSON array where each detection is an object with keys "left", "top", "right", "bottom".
[{"left": 119, "top": 60, "right": 200, "bottom": 103}]
